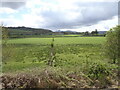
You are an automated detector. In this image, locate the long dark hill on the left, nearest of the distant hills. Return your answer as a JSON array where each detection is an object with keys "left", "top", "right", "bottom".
[{"left": 6, "top": 27, "right": 52, "bottom": 38}]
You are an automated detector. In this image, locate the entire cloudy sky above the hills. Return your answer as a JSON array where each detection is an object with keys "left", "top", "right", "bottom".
[{"left": 0, "top": 0, "right": 118, "bottom": 32}]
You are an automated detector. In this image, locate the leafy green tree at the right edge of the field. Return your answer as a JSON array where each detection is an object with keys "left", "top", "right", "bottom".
[{"left": 105, "top": 25, "right": 120, "bottom": 63}]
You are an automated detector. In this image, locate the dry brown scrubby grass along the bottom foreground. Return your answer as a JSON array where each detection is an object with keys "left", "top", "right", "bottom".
[{"left": 1, "top": 69, "right": 116, "bottom": 88}]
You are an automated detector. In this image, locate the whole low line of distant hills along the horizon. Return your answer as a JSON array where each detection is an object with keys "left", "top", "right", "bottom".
[{"left": 6, "top": 26, "right": 106, "bottom": 38}]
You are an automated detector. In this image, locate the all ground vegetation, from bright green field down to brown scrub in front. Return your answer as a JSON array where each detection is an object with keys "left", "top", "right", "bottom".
[{"left": 2, "top": 25, "right": 119, "bottom": 88}]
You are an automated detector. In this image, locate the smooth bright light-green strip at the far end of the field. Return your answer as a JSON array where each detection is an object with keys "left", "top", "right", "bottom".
[{"left": 8, "top": 37, "right": 105, "bottom": 45}]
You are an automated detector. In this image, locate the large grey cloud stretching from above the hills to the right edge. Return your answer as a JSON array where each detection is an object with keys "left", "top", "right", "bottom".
[{"left": 40, "top": 2, "right": 118, "bottom": 29}]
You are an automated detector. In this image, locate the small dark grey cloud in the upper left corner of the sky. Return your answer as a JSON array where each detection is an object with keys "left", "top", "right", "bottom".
[{"left": 1, "top": 2, "right": 26, "bottom": 9}]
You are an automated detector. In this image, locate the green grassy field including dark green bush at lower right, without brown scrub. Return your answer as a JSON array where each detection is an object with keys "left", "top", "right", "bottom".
[{"left": 3, "top": 37, "right": 118, "bottom": 88}]
